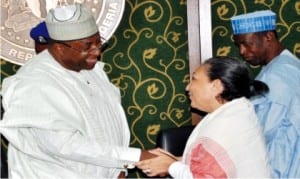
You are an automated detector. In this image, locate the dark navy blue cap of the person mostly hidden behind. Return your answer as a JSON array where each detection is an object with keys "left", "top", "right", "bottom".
[{"left": 30, "top": 21, "right": 50, "bottom": 44}]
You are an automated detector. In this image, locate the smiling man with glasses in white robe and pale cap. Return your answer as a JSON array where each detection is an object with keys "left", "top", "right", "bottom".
[{"left": 0, "top": 4, "right": 154, "bottom": 179}]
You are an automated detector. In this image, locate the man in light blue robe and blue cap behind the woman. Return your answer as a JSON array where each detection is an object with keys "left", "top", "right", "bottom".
[{"left": 231, "top": 10, "right": 300, "bottom": 178}]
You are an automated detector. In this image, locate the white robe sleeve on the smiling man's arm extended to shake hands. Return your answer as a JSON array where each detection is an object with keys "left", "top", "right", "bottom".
[{"left": 0, "top": 120, "right": 141, "bottom": 169}]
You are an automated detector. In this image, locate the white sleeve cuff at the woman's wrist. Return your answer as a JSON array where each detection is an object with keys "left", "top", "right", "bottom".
[{"left": 168, "top": 161, "right": 193, "bottom": 179}]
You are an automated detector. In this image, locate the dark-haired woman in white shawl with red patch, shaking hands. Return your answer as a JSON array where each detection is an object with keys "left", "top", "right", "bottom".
[{"left": 136, "top": 57, "right": 270, "bottom": 178}]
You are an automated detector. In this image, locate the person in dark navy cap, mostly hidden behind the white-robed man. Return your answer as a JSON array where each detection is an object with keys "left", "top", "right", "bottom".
[{"left": 30, "top": 21, "right": 50, "bottom": 54}]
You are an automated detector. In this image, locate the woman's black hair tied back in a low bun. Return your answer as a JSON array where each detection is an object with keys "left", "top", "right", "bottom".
[{"left": 203, "top": 57, "right": 269, "bottom": 101}]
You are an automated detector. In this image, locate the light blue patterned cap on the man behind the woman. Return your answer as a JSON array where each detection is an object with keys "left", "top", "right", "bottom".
[{"left": 231, "top": 10, "right": 276, "bottom": 35}]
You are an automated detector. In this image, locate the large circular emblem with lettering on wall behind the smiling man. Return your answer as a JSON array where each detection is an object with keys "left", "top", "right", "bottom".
[{"left": 0, "top": 0, "right": 125, "bottom": 65}]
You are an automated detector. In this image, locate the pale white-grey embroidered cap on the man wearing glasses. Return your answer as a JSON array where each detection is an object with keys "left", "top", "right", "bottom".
[{"left": 45, "top": 3, "right": 99, "bottom": 41}]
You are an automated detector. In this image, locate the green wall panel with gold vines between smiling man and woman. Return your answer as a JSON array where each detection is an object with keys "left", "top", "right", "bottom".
[{"left": 102, "top": 0, "right": 191, "bottom": 178}]
